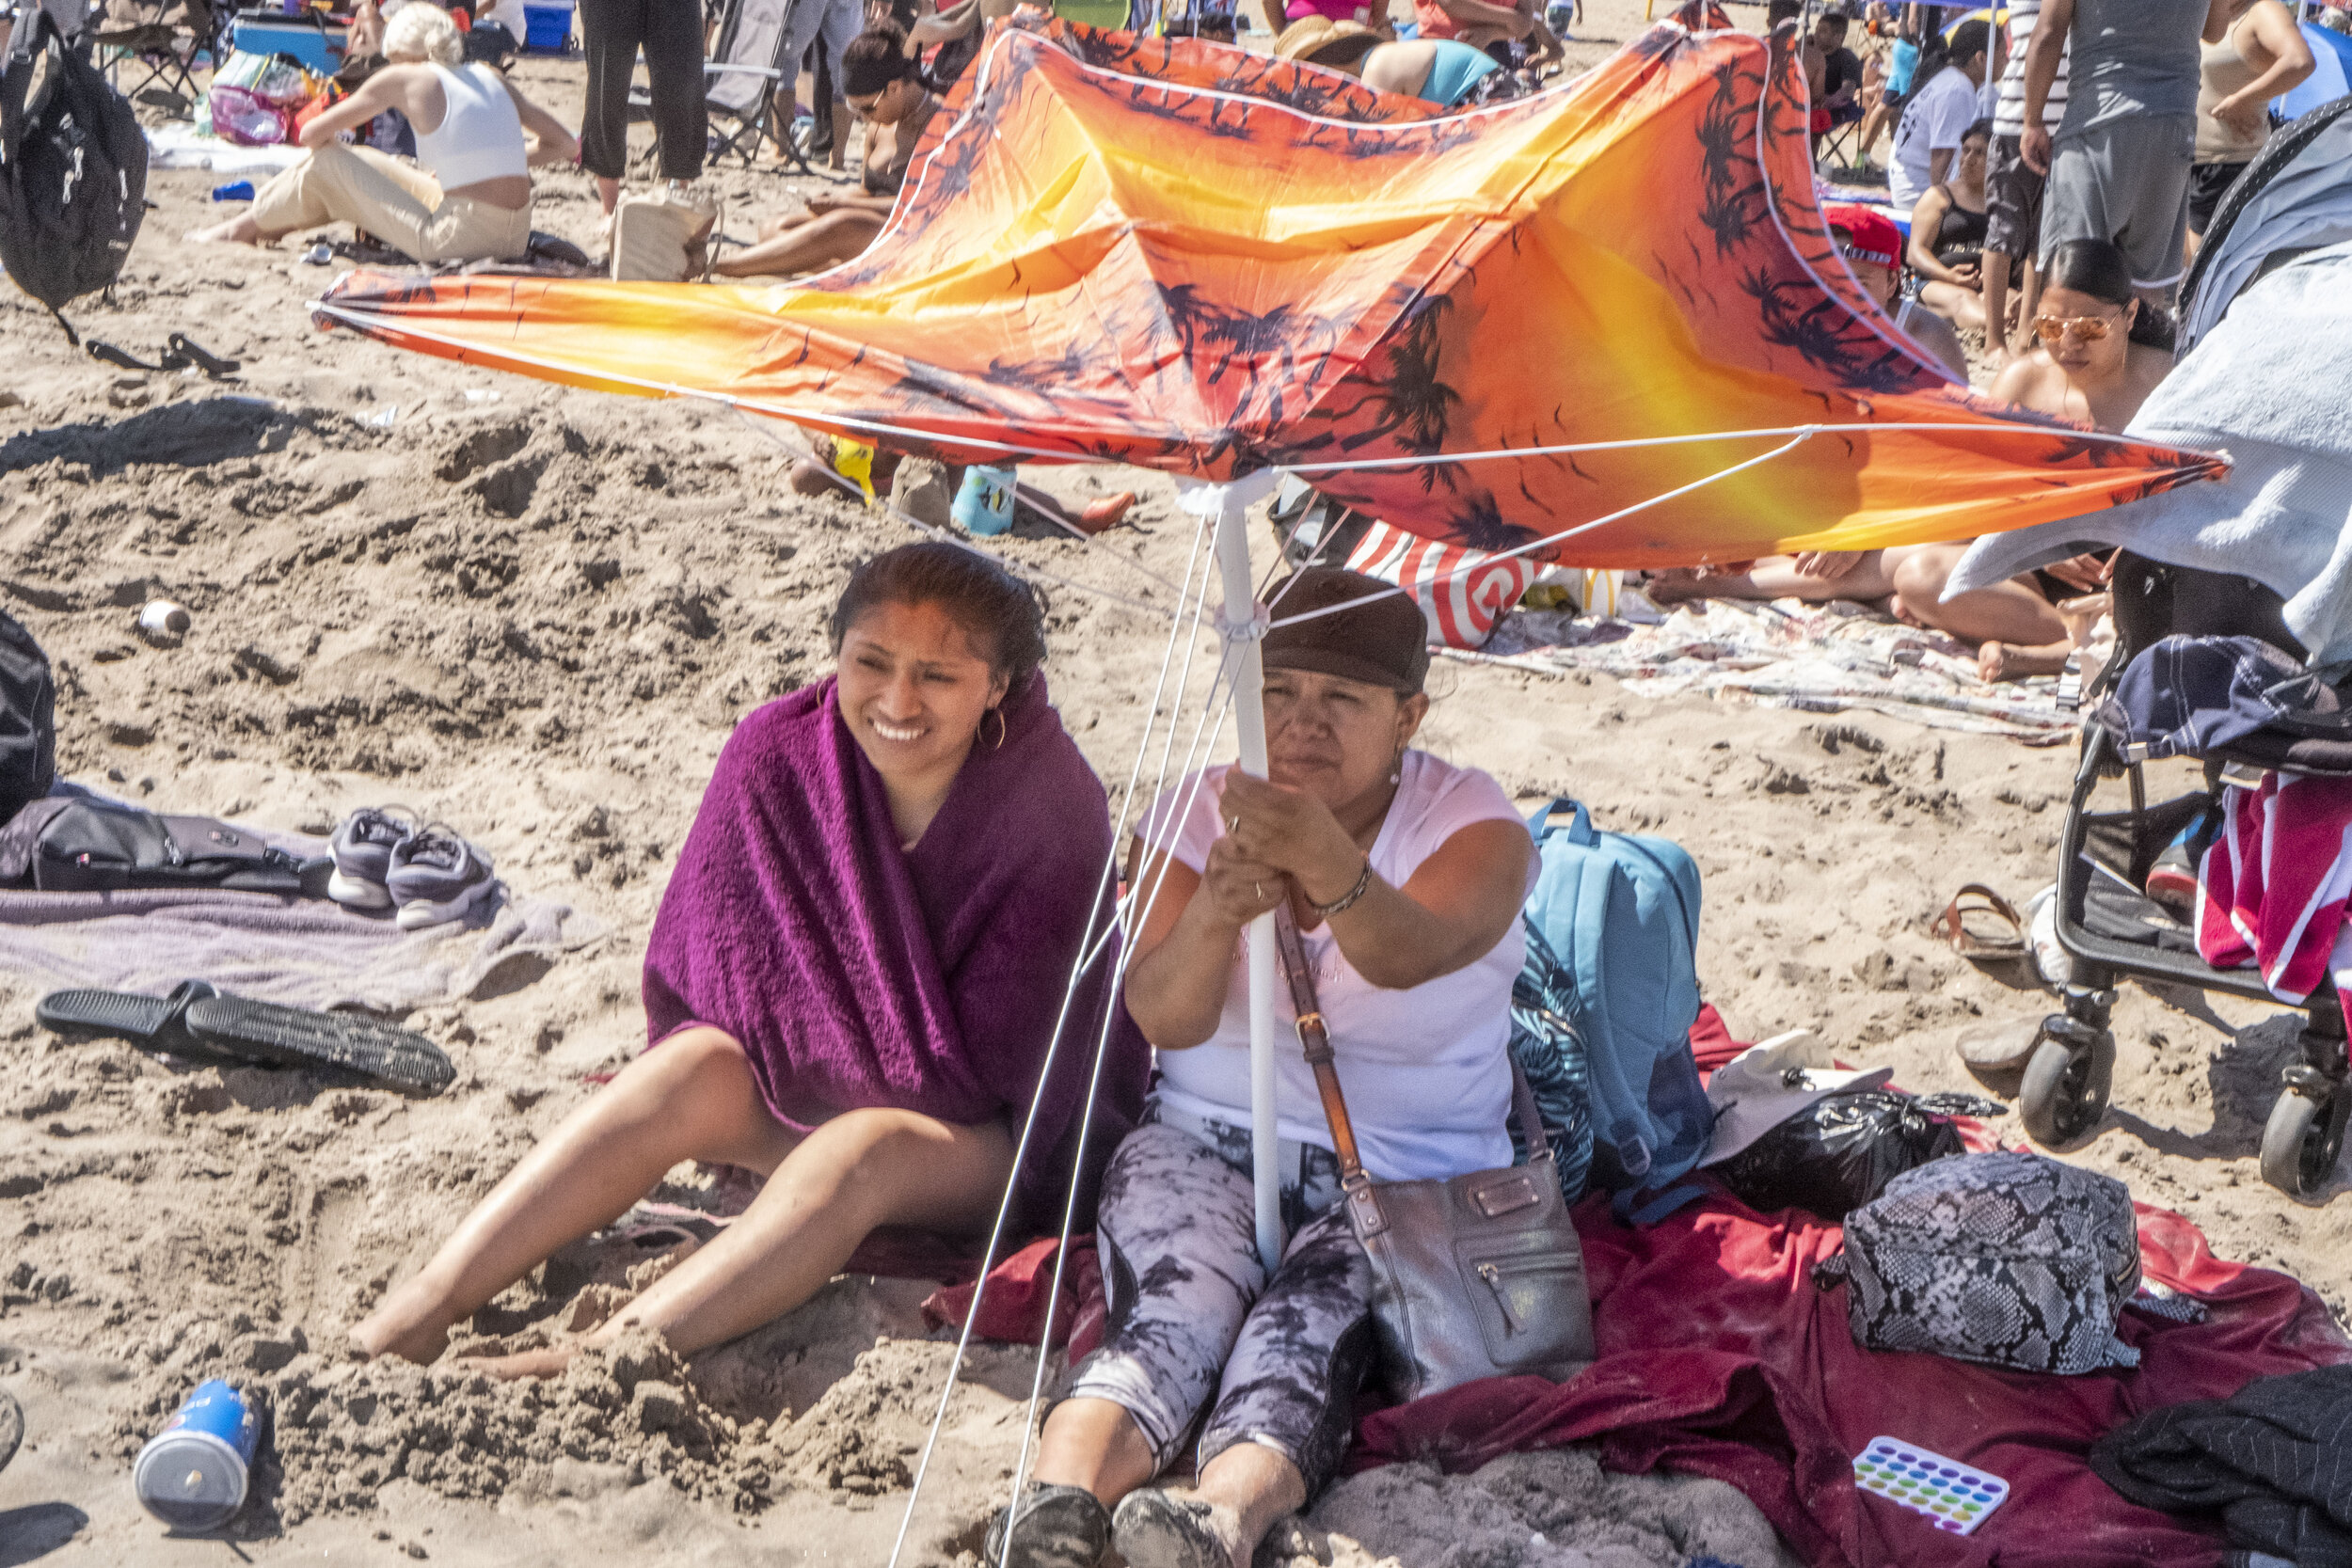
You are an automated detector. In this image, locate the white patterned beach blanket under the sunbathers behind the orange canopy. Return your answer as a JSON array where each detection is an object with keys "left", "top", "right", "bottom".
[{"left": 1452, "top": 599, "right": 2077, "bottom": 745}]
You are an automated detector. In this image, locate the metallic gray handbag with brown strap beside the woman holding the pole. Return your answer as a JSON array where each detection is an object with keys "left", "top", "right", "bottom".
[{"left": 1275, "top": 910, "right": 1593, "bottom": 1403}]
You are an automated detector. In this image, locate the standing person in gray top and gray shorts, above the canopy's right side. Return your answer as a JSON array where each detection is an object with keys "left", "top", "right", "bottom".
[{"left": 2021, "top": 0, "right": 2230, "bottom": 306}]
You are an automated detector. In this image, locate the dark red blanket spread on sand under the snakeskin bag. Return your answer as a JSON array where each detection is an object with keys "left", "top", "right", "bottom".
[{"left": 927, "top": 1008, "right": 2352, "bottom": 1568}]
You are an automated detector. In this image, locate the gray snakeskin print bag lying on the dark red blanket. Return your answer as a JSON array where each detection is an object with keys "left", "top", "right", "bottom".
[{"left": 1814, "top": 1149, "right": 2140, "bottom": 1373}]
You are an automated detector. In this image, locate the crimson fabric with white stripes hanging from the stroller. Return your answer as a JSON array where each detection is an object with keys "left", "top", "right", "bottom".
[{"left": 2197, "top": 773, "right": 2352, "bottom": 1006}]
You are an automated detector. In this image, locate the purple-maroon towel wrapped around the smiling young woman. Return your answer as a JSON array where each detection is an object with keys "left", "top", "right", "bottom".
[{"left": 644, "top": 674, "right": 1151, "bottom": 1229}]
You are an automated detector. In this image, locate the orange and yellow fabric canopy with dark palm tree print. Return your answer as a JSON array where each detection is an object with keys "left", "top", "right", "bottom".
[{"left": 318, "top": 5, "right": 2223, "bottom": 566}]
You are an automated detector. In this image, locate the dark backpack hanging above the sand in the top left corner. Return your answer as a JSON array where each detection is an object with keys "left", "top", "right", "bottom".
[{"left": 0, "top": 11, "right": 146, "bottom": 343}]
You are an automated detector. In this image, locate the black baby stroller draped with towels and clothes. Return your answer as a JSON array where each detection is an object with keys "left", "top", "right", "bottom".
[{"left": 2018, "top": 99, "right": 2352, "bottom": 1196}]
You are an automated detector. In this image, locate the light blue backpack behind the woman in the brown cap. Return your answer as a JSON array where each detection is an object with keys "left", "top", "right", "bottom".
[{"left": 1510, "top": 797, "right": 1715, "bottom": 1225}]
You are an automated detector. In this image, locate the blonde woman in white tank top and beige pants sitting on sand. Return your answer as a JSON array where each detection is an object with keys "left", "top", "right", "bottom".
[{"left": 188, "top": 2, "right": 579, "bottom": 263}]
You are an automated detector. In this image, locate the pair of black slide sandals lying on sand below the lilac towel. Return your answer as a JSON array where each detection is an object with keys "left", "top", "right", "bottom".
[{"left": 33, "top": 980, "right": 456, "bottom": 1093}]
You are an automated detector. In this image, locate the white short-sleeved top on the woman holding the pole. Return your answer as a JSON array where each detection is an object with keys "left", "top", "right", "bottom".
[{"left": 1136, "top": 752, "right": 1536, "bottom": 1180}]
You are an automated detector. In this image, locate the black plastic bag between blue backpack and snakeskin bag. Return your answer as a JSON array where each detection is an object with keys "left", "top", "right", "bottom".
[{"left": 1712, "top": 1088, "right": 2004, "bottom": 1220}]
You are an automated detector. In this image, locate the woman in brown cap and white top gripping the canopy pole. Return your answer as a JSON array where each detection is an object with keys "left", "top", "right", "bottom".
[{"left": 1011, "top": 566, "right": 1536, "bottom": 1568}]
